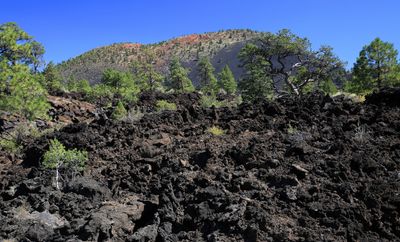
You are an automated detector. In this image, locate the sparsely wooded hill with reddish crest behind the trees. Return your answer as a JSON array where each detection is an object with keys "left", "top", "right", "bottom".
[{"left": 58, "top": 30, "right": 263, "bottom": 84}]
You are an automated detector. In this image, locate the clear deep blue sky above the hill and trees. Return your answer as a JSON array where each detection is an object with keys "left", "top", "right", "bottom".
[{"left": 0, "top": 0, "right": 400, "bottom": 67}]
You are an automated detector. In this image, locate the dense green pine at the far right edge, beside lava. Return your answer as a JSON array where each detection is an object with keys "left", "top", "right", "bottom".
[{"left": 347, "top": 38, "right": 400, "bottom": 94}]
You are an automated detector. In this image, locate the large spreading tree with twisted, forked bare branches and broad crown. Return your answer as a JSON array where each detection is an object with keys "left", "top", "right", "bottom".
[{"left": 240, "top": 29, "right": 343, "bottom": 95}]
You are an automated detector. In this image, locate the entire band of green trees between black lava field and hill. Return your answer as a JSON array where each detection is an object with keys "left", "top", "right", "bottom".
[{"left": 0, "top": 23, "right": 400, "bottom": 119}]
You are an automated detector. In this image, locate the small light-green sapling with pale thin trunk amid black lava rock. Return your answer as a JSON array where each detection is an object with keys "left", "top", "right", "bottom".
[{"left": 42, "top": 139, "right": 88, "bottom": 190}]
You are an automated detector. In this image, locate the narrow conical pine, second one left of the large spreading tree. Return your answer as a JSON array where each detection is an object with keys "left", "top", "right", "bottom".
[{"left": 198, "top": 57, "right": 218, "bottom": 96}]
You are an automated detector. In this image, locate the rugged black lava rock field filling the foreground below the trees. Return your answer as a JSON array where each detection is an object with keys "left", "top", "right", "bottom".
[{"left": 0, "top": 90, "right": 400, "bottom": 241}]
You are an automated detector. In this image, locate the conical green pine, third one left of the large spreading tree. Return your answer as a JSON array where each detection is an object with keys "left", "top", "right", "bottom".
[{"left": 169, "top": 57, "right": 195, "bottom": 93}]
